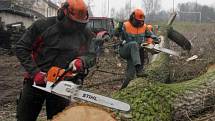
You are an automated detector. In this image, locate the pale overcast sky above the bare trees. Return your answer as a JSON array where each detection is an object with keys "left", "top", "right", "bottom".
[{"left": 85, "top": 0, "right": 215, "bottom": 16}]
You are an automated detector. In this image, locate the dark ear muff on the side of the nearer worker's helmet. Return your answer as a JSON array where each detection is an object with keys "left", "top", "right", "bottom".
[{"left": 57, "top": 2, "right": 69, "bottom": 21}]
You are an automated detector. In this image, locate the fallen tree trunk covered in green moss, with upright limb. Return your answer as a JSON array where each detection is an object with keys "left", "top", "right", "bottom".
[{"left": 113, "top": 12, "right": 215, "bottom": 121}]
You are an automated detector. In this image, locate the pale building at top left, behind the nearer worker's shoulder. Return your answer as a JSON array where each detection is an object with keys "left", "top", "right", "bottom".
[{"left": 0, "top": 0, "right": 59, "bottom": 27}]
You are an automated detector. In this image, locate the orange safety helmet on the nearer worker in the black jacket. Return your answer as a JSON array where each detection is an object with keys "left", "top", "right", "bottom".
[{"left": 58, "top": 0, "right": 89, "bottom": 23}]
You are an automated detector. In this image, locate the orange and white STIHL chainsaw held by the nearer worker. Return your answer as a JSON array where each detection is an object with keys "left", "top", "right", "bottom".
[{"left": 33, "top": 67, "right": 130, "bottom": 111}]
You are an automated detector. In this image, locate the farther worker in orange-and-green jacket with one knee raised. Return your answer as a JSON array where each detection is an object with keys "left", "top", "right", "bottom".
[{"left": 119, "top": 9, "right": 159, "bottom": 89}]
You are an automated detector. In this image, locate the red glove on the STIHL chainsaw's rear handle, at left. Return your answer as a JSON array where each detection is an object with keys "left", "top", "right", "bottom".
[{"left": 33, "top": 71, "right": 46, "bottom": 86}]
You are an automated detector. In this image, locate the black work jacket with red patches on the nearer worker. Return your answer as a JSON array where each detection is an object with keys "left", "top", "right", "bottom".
[{"left": 16, "top": 17, "right": 96, "bottom": 75}]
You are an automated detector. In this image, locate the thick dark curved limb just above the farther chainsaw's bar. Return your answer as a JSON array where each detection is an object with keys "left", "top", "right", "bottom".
[{"left": 168, "top": 28, "right": 192, "bottom": 50}]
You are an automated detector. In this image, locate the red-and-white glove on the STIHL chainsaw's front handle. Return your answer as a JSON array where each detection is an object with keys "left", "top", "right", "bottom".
[{"left": 69, "top": 58, "right": 84, "bottom": 72}]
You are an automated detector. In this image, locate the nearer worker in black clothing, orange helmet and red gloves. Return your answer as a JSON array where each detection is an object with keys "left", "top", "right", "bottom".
[{"left": 16, "top": 0, "right": 96, "bottom": 121}]
